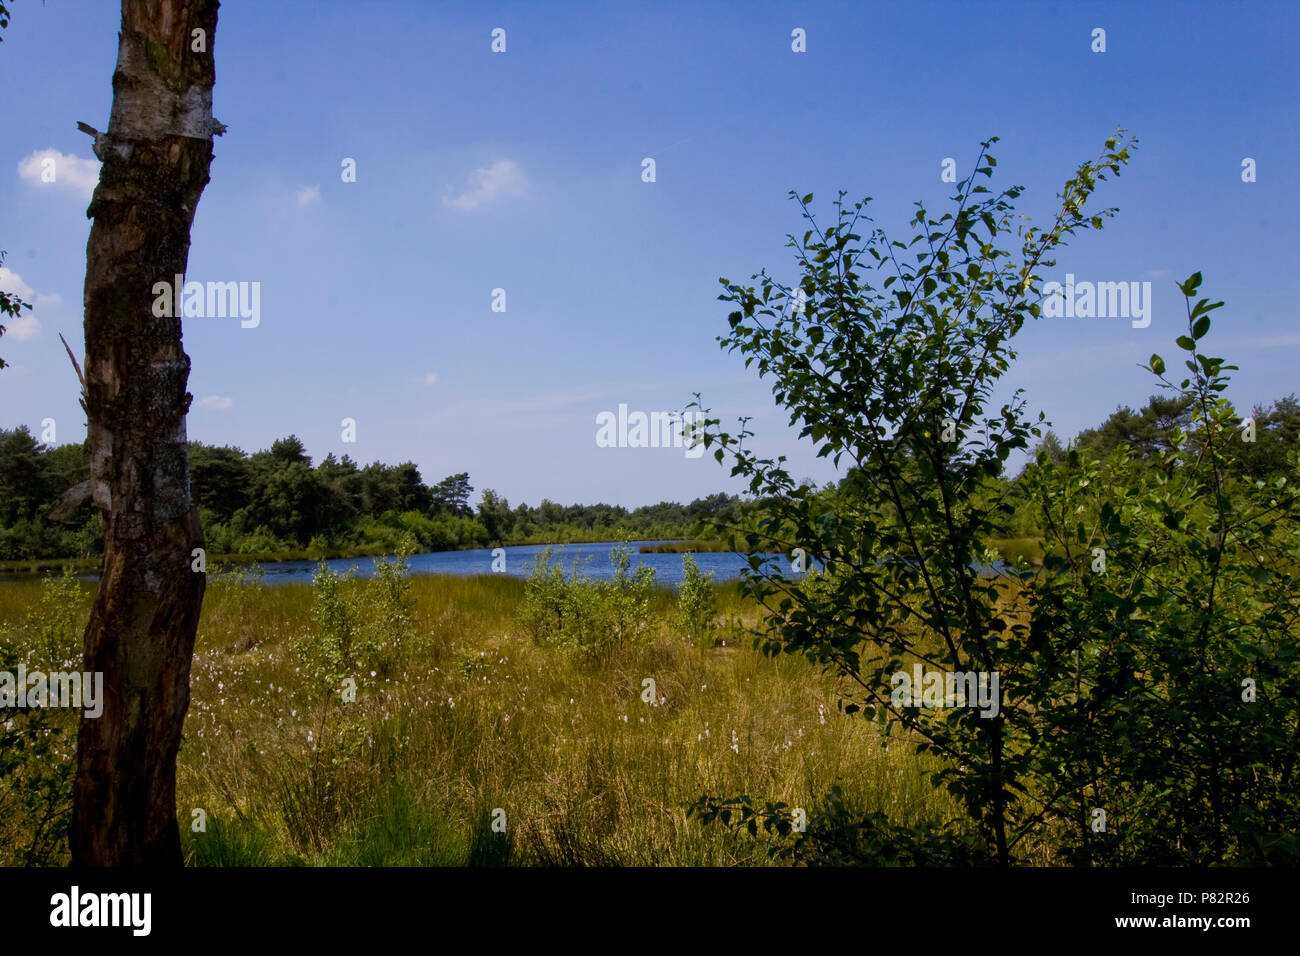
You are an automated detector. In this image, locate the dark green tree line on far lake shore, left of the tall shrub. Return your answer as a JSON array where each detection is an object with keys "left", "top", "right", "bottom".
[{"left": 0, "top": 425, "right": 742, "bottom": 561}]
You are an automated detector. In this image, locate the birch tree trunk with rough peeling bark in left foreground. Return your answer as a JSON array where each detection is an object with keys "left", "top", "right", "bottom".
[{"left": 72, "top": 0, "right": 224, "bottom": 866}]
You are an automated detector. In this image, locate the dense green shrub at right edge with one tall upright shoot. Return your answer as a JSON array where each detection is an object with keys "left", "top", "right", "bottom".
[{"left": 1011, "top": 273, "right": 1300, "bottom": 866}]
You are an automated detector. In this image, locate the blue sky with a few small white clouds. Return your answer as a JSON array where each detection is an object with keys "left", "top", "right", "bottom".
[{"left": 0, "top": 0, "right": 1300, "bottom": 506}]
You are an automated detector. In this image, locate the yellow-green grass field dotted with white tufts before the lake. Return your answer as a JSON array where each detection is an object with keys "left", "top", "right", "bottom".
[{"left": 0, "top": 567, "right": 954, "bottom": 865}]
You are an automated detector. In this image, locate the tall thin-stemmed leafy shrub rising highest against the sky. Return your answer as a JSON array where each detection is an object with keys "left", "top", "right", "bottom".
[{"left": 690, "top": 135, "right": 1130, "bottom": 865}]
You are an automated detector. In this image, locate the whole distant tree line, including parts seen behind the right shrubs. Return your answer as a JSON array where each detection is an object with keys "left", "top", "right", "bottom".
[{"left": 0, "top": 393, "right": 1300, "bottom": 561}]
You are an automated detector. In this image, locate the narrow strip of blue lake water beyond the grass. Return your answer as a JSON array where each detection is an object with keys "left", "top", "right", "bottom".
[{"left": 233, "top": 541, "right": 780, "bottom": 584}]
